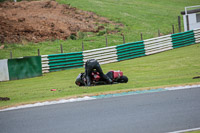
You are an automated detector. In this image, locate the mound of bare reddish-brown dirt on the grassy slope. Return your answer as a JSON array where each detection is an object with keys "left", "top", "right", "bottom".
[{"left": 0, "top": 1, "right": 123, "bottom": 43}]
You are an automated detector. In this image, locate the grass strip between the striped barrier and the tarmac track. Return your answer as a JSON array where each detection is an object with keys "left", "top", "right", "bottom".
[{"left": 0, "top": 44, "right": 200, "bottom": 108}]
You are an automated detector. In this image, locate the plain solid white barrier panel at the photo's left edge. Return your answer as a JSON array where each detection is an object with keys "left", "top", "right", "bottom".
[{"left": 0, "top": 59, "right": 9, "bottom": 81}]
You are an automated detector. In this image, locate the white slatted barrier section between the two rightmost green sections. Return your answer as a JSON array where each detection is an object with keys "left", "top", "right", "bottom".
[{"left": 144, "top": 35, "right": 173, "bottom": 55}]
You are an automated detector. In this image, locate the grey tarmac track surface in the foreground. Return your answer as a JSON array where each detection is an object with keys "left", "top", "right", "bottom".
[{"left": 0, "top": 88, "right": 200, "bottom": 133}]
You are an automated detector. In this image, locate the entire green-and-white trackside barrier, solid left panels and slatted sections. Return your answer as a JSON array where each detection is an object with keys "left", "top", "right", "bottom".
[{"left": 0, "top": 29, "right": 200, "bottom": 81}]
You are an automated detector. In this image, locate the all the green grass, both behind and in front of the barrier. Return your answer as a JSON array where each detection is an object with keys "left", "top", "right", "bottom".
[{"left": 0, "top": 0, "right": 200, "bottom": 108}]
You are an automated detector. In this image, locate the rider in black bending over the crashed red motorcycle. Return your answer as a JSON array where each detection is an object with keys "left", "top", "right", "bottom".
[{"left": 75, "top": 59, "right": 112, "bottom": 86}]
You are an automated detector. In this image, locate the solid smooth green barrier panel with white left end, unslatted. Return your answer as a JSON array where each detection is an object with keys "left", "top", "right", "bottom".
[{"left": 0, "top": 56, "right": 42, "bottom": 81}]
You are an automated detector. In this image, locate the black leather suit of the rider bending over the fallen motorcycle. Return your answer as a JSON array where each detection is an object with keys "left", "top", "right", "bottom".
[{"left": 85, "top": 59, "right": 112, "bottom": 86}]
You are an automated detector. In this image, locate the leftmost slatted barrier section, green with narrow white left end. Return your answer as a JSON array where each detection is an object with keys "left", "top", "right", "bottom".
[{"left": 41, "top": 52, "right": 83, "bottom": 73}]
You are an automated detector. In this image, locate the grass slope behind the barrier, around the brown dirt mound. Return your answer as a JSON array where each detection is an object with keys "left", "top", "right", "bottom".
[{"left": 0, "top": 0, "right": 199, "bottom": 59}]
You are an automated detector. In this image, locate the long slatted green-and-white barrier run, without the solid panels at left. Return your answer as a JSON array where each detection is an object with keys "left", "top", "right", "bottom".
[{"left": 39, "top": 29, "right": 200, "bottom": 73}]
